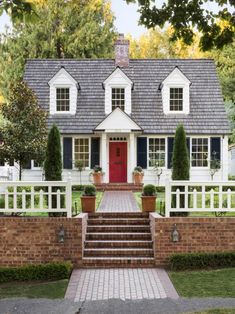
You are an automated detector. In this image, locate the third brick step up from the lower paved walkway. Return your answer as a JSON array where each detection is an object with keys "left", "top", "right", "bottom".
[{"left": 85, "top": 240, "right": 153, "bottom": 249}]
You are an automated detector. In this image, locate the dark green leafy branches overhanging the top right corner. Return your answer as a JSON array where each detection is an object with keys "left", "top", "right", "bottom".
[{"left": 126, "top": 0, "right": 235, "bottom": 51}]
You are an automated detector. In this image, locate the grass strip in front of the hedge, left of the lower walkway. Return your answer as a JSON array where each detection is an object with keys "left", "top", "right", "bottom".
[{"left": 0, "top": 279, "right": 69, "bottom": 299}]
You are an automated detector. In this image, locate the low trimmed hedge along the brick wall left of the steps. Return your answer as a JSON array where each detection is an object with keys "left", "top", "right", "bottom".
[{"left": 0, "top": 262, "right": 73, "bottom": 283}]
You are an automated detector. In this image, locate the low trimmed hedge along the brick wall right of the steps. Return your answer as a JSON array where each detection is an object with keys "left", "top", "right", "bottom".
[{"left": 169, "top": 252, "right": 235, "bottom": 270}]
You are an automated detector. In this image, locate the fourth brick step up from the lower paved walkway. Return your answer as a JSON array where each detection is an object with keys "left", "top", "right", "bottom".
[{"left": 86, "top": 232, "right": 152, "bottom": 241}]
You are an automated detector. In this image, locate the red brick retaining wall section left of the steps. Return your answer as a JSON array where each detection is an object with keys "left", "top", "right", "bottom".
[{"left": 0, "top": 214, "right": 87, "bottom": 267}]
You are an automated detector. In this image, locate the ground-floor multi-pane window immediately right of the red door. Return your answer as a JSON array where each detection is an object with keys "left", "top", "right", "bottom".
[{"left": 148, "top": 138, "right": 166, "bottom": 167}]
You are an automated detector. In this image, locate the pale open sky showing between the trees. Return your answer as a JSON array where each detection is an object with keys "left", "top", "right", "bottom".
[{"left": 0, "top": 0, "right": 146, "bottom": 38}]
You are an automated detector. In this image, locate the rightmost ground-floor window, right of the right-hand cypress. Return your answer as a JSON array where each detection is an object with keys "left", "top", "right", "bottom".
[{"left": 191, "top": 137, "right": 209, "bottom": 167}]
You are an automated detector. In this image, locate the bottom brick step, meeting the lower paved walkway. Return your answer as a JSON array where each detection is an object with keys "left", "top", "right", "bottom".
[{"left": 83, "top": 257, "right": 155, "bottom": 268}]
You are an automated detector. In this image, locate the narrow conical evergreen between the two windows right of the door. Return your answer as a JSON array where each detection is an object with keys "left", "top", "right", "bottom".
[{"left": 172, "top": 124, "right": 189, "bottom": 180}]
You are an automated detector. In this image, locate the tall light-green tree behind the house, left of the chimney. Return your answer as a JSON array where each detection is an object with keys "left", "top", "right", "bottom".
[{"left": 0, "top": 0, "right": 115, "bottom": 99}]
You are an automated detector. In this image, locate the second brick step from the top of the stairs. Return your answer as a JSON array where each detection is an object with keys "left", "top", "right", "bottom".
[{"left": 87, "top": 218, "right": 149, "bottom": 226}]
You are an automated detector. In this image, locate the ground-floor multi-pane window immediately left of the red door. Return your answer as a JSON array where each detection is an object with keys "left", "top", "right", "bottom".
[{"left": 74, "top": 138, "right": 90, "bottom": 168}]
